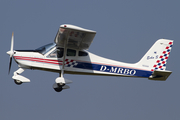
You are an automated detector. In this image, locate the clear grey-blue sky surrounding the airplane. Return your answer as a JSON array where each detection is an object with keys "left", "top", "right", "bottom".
[{"left": 0, "top": 0, "right": 180, "bottom": 120}]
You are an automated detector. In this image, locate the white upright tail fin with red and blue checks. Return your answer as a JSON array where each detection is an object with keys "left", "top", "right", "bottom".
[{"left": 137, "top": 39, "right": 173, "bottom": 71}]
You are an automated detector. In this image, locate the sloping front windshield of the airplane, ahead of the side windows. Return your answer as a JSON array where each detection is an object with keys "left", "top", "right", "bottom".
[{"left": 35, "top": 43, "right": 56, "bottom": 55}]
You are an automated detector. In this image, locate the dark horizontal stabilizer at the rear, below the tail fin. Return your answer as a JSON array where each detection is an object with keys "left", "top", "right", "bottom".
[{"left": 148, "top": 70, "right": 172, "bottom": 81}]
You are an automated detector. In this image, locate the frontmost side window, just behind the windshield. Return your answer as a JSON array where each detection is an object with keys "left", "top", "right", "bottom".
[{"left": 48, "top": 48, "right": 64, "bottom": 58}]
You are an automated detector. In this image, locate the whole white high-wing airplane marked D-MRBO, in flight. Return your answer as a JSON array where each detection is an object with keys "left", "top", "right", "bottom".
[{"left": 7, "top": 24, "right": 173, "bottom": 92}]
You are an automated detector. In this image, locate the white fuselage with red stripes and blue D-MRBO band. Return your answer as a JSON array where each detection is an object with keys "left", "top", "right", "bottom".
[{"left": 14, "top": 43, "right": 152, "bottom": 77}]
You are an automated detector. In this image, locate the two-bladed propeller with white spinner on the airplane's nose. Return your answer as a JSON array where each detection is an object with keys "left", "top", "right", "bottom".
[{"left": 7, "top": 32, "right": 14, "bottom": 74}]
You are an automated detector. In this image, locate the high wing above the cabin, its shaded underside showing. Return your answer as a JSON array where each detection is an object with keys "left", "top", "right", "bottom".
[{"left": 54, "top": 24, "right": 96, "bottom": 50}]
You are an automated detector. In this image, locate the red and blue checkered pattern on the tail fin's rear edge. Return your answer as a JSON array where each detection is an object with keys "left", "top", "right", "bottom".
[{"left": 151, "top": 42, "right": 173, "bottom": 71}]
